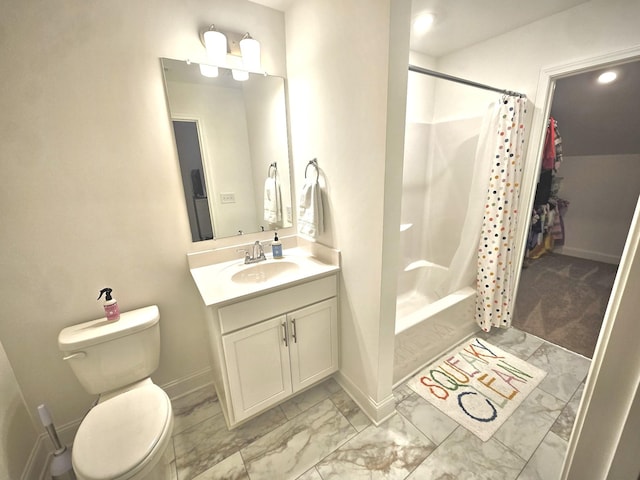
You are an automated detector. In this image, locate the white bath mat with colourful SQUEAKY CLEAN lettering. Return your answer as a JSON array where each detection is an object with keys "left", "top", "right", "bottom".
[{"left": 407, "top": 338, "right": 547, "bottom": 442}]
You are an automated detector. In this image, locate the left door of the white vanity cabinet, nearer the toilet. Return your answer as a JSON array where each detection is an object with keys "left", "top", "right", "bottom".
[{"left": 222, "top": 315, "right": 292, "bottom": 422}]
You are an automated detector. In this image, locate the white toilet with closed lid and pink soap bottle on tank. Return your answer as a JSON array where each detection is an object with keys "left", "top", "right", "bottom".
[{"left": 58, "top": 305, "right": 173, "bottom": 480}]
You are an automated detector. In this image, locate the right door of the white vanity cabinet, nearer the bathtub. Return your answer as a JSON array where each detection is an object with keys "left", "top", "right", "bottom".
[{"left": 287, "top": 298, "right": 338, "bottom": 392}]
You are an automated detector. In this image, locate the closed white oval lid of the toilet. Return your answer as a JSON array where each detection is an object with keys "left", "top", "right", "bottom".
[{"left": 72, "top": 384, "right": 172, "bottom": 480}]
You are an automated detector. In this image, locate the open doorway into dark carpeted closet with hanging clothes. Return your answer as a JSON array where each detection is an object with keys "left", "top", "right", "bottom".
[{"left": 513, "top": 57, "right": 640, "bottom": 358}]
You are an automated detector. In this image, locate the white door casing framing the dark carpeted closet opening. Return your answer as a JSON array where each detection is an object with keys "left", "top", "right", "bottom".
[{"left": 515, "top": 47, "right": 640, "bottom": 480}]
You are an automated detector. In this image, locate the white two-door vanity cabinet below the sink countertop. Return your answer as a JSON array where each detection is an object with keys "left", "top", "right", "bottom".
[{"left": 210, "top": 275, "right": 338, "bottom": 427}]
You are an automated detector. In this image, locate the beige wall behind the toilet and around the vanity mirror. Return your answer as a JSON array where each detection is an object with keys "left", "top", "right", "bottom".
[{"left": 0, "top": 0, "right": 286, "bottom": 436}]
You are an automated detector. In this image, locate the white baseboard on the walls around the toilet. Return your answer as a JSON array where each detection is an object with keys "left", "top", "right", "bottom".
[{"left": 27, "top": 367, "right": 213, "bottom": 480}]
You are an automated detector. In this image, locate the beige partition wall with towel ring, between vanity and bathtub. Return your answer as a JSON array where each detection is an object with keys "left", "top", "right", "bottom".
[{"left": 285, "top": 0, "right": 409, "bottom": 417}]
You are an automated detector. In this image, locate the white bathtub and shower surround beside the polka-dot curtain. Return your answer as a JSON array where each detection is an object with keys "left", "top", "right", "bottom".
[{"left": 393, "top": 117, "right": 482, "bottom": 384}]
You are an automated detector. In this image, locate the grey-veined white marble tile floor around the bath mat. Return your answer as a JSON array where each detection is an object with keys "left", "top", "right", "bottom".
[{"left": 173, "top": 328, "right": 590, "bottom": 480}]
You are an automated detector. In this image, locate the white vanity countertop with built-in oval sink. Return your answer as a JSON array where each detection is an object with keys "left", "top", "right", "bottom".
[{"left": 190, "top": 248, "right": 340, "bottom": 306}]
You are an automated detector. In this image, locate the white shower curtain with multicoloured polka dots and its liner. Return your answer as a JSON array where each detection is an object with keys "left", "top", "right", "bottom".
[{"left": 441, "top": 95, "right": 526, "bottom": 331}]
